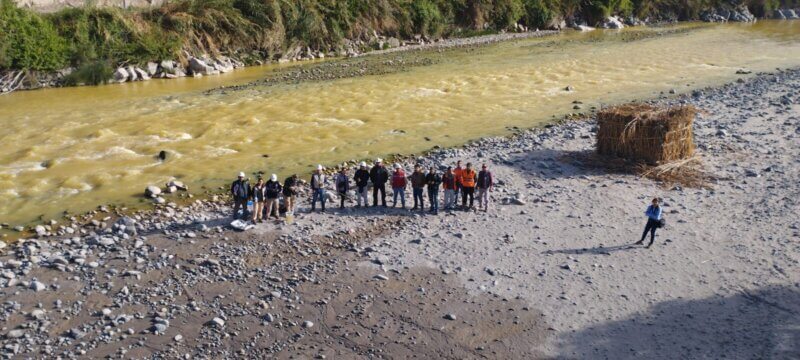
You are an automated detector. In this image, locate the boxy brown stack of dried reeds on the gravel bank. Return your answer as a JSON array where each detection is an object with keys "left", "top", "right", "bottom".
[{"left": 597, "top": 103, "right": 697, "bottom": 164}]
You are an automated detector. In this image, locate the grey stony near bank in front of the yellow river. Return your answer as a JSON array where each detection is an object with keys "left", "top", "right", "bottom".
[{"left": 0, "top": 65, "right": 800, "bottom": 358}]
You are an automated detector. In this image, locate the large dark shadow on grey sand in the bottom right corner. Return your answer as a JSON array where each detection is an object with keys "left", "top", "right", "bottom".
[{"left": 561, "top": 285, "right": 800, "bottom": 359}]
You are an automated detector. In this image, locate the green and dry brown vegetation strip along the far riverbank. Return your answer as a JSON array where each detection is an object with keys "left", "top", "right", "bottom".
[{"left": 0, "top": 0, "right": 798, "bottom": 76}]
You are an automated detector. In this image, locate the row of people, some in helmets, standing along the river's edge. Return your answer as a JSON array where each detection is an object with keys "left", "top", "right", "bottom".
[{"left": 231, "top": 159, "right": 494, "bottom": 222}]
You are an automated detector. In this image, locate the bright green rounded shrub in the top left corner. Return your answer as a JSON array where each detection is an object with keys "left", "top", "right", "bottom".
[{"left": 0, "top": 0, "right": 67, "bottom": 70}]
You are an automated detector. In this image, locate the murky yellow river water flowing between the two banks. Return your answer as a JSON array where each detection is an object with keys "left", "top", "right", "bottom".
[{"left": 0, "top": 21, "right": 800, "bottom": 224}]
